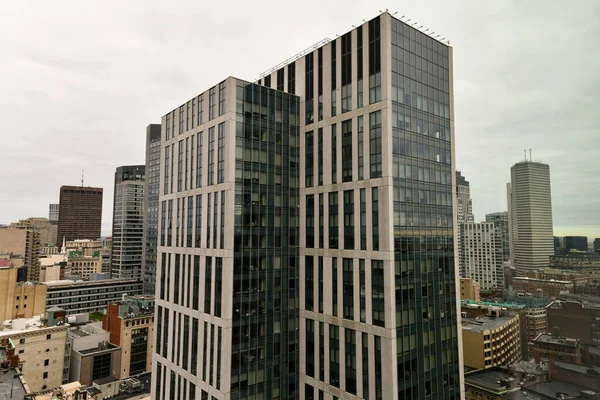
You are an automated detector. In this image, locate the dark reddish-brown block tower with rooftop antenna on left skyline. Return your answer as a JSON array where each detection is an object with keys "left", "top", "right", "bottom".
[{"left": 57, "top": 186, "right": 102, "bottom": 243}]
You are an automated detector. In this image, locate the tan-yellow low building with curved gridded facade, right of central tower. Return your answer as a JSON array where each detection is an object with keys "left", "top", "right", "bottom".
[{"left": 462, "top": 307, "right": 521, "bottom": 369}]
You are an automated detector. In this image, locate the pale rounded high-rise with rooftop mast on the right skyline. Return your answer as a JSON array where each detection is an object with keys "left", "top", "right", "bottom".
[{"left": 508, "top": 161, "right": 554, "bottom": 276}]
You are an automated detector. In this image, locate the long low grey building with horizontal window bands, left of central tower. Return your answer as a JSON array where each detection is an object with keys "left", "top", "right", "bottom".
[{"left": 46, "top": 279, "right": 142, "bottom": 314}]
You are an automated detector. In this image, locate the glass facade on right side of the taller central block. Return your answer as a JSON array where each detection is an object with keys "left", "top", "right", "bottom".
[{"left": 390, "top": 14, "right": 461, "bottom": 399}]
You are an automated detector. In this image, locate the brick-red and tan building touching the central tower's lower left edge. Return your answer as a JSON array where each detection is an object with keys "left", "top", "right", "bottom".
[{"left": 102, "top": 295, "right": 154, "bottom": 379}]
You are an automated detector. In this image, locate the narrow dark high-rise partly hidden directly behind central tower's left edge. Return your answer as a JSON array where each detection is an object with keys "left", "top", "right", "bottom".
[{"left": 142, "top": 124, "right": 161, "bottom": 295}]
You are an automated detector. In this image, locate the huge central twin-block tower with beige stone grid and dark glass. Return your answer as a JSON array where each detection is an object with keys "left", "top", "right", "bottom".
[{"left": 152, "top": 13, "right": 462, "bottom": 399}]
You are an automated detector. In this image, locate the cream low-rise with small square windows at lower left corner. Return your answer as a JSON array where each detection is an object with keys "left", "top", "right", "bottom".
[{"left": 0, "top": 317, "right": 68, "bottom": 392}]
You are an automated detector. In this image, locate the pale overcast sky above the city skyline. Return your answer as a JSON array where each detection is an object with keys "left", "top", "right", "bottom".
[{"left": 0, "top": 0, "right": 600, "bottom": 237}]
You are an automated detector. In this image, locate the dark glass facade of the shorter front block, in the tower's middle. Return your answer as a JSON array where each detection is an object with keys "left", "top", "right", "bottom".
[{"left": 231, "top": 81, "right": 299, "bottom": 399}]
